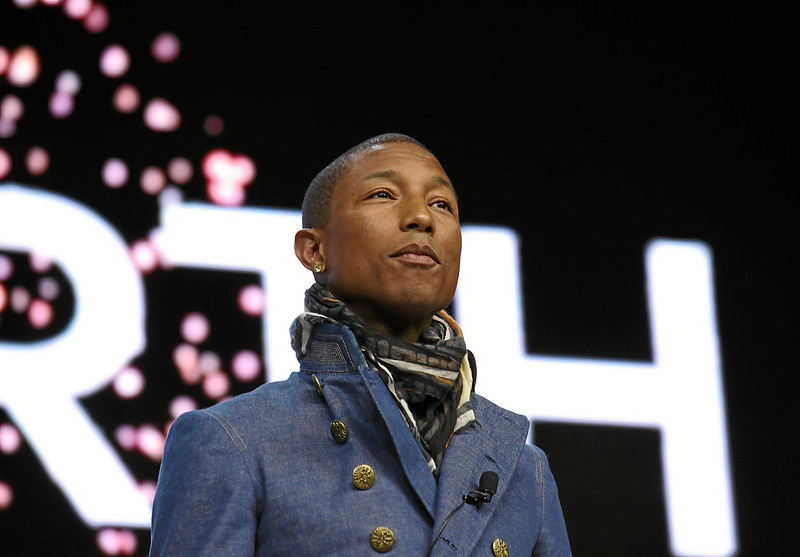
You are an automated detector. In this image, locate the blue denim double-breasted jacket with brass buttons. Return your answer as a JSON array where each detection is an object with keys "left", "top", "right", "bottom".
[{"left": 150, "top": 324, "right": 571, "bottom": 557}]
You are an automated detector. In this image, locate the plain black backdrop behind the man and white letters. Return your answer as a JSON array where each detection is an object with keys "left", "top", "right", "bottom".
[{"left": 0, "top": 0, "right": 800, "bottom": 557}]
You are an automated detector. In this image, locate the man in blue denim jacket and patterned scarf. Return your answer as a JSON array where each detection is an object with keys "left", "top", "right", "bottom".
[{"left": 151, "top": 134, "right": 570, "bottom": 557}]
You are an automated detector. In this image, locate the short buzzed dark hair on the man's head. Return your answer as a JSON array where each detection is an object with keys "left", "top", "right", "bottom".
[{"left": 302, "top": 133, "right": 433, "bottom": 228}]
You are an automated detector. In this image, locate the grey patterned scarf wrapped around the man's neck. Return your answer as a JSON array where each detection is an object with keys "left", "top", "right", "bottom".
[{"left": 292, "top": 284, "right": 475, "bottom": 476}]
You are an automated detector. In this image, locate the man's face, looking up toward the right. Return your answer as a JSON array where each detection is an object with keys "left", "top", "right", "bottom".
[{"left": 320, "top": 143, "right": 461, "bottom": 329}]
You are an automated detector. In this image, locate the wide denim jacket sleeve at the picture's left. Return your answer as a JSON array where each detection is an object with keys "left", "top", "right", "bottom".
[{"left": 150, "top": 411, "right": 253, "bottom": 557}]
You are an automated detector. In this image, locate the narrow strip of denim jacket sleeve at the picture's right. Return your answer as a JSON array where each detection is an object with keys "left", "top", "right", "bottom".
[{"left": 532, "top": 446, "right": 572, "bottom": 557}]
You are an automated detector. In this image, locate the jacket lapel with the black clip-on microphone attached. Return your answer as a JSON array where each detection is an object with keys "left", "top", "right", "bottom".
[{"left": 431, "top": 395, "right": 530, "bottom": 555}]
